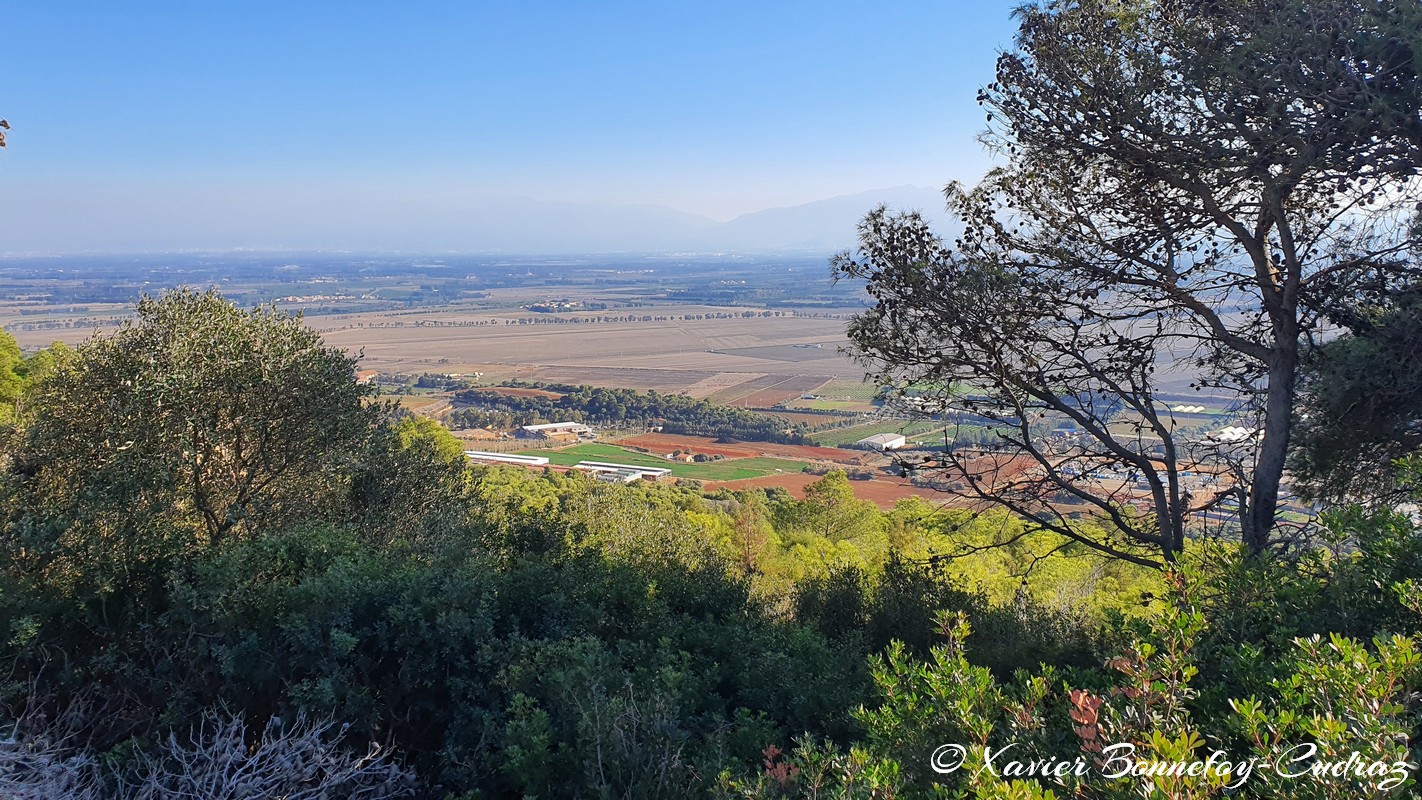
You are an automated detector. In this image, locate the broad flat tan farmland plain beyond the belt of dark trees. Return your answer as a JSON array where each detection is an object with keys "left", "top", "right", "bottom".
[{"left": 0, "top": 274, "right": 881, "bottom": 406}]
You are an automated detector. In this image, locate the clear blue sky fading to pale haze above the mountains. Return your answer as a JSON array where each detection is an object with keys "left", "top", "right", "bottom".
[{"left": 0, "top": 0, "right": 1012, "bottom": 253}]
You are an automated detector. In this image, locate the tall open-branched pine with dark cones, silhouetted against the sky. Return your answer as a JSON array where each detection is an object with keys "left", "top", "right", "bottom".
[{"left": 833, "top": 0, "right": 1422, "bottom": 564}]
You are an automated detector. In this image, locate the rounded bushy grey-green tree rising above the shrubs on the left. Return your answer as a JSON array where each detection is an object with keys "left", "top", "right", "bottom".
[{"left": 11, "top": 288, "right": 380, "bottom": 557}]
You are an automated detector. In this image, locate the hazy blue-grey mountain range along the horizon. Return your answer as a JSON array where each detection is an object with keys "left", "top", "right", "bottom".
[{"left": 0, "top": 186, "right": 946, "bottom": 254}]
